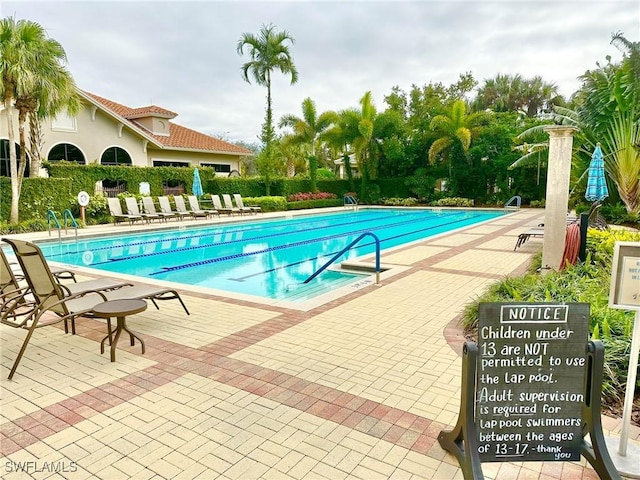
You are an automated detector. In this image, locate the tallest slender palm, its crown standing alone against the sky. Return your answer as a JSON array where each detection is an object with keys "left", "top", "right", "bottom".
[{"left": 237, "top": 24, "right": 298, "bottom": 151}]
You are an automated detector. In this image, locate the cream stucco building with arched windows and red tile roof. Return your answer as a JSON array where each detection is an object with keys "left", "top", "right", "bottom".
[{"left": 0, "top": 90, "right": 253, "bottom": 182}]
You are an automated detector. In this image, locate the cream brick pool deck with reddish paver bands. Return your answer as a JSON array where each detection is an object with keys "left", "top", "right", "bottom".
[{"left": 0, "top": 209, "right": 640, "bottom": 480}]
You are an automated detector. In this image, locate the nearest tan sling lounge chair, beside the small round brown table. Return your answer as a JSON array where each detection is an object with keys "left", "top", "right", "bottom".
[{"left": 3, "top": 238, "right": 189, "bottom": 379}]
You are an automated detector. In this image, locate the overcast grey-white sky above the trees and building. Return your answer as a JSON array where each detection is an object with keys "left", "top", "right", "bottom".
[{"left": 0, "top": 0, "right": 640, "bottom": 143}]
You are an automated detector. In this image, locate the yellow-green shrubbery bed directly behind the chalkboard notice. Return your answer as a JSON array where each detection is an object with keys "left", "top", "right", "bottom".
[{"left": 462, "top": 229, "right": 640, "bottom": 403}]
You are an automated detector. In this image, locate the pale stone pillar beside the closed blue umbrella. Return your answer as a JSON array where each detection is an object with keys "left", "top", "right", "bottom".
[{"left": 542, "top": 125, "right": 578, "bottom": 271}]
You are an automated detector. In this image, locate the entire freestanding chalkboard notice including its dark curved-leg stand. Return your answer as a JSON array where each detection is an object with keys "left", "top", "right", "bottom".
[{"left": 438, "top": 303, "right": 620, "bottom": 479}]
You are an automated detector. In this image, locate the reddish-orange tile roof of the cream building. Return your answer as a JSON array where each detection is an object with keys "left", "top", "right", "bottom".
[{"left": 82, "top": 90, "right": 253, "bottom": 155}]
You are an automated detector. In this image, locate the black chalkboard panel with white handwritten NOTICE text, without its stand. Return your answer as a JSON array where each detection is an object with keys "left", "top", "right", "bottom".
[{"left": 475, "top": 303, "right": 589, "bottom": 462}]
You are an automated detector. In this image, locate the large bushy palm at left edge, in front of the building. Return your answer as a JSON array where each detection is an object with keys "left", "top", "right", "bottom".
[{"left": 0, "top": 17, "right": 75, "bottom": 223}]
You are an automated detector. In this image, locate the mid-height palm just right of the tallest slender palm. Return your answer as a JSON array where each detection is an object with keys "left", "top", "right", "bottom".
[{"left": 280, "top": 97, "right": 337, "bottom": 192}]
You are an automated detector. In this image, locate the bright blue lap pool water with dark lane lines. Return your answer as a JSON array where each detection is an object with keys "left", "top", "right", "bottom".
[{"left": 41, "top": 209, "right": 504, "bottom": 301}]
